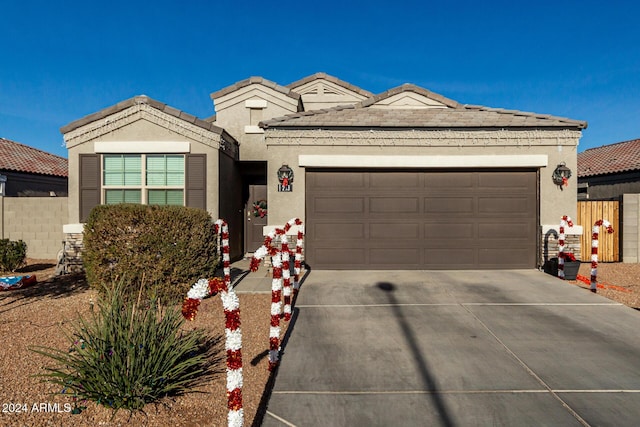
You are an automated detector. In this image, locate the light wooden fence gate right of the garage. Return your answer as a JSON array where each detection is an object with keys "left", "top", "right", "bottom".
[{"left": 575, "top": 201, "right": 621, "bottom": 262}]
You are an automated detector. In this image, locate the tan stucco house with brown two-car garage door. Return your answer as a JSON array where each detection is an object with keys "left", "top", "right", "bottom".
[{"left": 61, "top": 73, "right": 587, "bottom": 270}]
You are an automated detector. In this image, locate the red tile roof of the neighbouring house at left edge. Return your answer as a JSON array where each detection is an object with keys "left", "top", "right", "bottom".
[{"left": 0, "top": 138, "right": 69, "bottom": 178}]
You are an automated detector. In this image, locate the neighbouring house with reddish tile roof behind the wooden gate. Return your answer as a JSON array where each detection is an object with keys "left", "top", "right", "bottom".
[{"left": 578, "top": 139, "right": 640, "bottom": 200}]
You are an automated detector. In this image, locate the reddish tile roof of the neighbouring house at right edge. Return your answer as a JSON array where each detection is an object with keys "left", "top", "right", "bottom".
[{"left": 578, "top": 139, "right": 640, "bottom": 178}]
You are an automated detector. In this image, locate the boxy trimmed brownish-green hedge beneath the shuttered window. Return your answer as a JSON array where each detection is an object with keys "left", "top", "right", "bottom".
[{"left": 82, "top": 204, "right": 220, "bottom": 303}]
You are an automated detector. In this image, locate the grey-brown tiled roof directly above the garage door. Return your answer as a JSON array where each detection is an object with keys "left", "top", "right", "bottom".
[{"left": 260, "top": 84, "right": 587, "bottom": 129}]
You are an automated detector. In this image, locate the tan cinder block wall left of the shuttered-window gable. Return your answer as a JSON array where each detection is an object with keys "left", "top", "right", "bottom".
[{"left": 0, "top": 197, "right": 69, "bottom": 260}]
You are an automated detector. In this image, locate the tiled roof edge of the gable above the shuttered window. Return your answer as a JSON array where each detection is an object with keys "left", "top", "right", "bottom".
[{"left": 60, "top": 95, "right": 224, "bottom": 134}]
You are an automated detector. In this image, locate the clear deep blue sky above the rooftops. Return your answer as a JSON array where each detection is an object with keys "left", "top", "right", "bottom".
[{"left": 0, "top": 0, "right": 640, "bottom": 157}]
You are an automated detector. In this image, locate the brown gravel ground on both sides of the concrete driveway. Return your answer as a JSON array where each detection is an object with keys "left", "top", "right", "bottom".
[{"left": 0, "top": 260, "right": 640, "bottom": 427}]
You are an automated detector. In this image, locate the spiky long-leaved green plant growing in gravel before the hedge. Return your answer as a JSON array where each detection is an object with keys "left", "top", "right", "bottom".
[{"left": 31, "top": 285, "right": 222, "bottom": 410}]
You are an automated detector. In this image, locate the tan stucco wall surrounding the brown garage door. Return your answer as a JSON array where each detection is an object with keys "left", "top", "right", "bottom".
[{"left": 266, "top": 130, "right": 581, "bottom": 234}]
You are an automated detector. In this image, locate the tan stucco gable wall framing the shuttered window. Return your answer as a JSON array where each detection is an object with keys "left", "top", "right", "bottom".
[{"left": 67, "top": 113, "right": 220, "bottom": 224}]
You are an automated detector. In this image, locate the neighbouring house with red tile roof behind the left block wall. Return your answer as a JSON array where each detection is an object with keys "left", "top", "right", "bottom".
[{"left": 0, "top": 138, "right": 68, "bottom": 197}]
